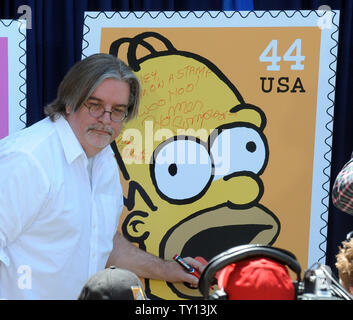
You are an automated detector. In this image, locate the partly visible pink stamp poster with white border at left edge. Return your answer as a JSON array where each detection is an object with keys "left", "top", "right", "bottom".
[{"left": 0, "top": 20, "right": 26, "bottom": 139}]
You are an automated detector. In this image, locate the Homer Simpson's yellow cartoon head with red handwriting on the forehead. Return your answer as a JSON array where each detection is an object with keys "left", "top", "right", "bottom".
[{"left": 110, "top": 33, "right": 280, "bottom": 300}]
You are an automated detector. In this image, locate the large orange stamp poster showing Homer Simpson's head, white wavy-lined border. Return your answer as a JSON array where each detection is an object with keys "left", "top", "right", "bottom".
[{"left": 83, "top": 11, "right": 339, "bottom": 299}]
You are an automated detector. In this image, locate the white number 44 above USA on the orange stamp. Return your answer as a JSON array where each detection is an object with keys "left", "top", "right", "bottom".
[{"left": 259, "top": 39, "right": 305, "bottom": 71}]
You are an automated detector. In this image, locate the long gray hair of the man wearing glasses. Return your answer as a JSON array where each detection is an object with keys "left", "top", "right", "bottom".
[{"left": 44, "top": 53, "right": 141, "bottom": 121}]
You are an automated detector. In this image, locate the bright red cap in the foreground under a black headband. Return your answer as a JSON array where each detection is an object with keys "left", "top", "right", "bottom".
[{"left": 218, "top": 258, "right": 295, "bottom": 300}]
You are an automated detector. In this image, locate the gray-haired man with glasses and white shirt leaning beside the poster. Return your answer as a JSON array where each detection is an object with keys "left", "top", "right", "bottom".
[{"left": 0, "top": 54, "right": 202, "bottom": 299}]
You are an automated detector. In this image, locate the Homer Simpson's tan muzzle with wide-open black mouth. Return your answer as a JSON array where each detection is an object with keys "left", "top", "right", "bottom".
[{"left": 159, "top": 204, "right": 280, "bottom": 299}]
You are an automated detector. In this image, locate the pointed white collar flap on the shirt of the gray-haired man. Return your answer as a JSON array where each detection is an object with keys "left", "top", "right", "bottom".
[{"left": 54, "top": 116, "right": 87, "bottom": 164}]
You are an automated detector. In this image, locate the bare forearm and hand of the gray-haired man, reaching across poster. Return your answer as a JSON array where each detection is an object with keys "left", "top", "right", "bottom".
[{"left": 106, "top": 232, "right": 204, "bottom": 286}]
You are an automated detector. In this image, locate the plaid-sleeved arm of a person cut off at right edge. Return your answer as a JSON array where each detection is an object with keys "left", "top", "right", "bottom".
[{"left": 332, "top": 159, "right": 353, "bottom": 214}]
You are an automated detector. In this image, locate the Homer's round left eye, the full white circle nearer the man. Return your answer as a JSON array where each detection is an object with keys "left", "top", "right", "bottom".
[{"left": 151, "top": 137, "right": 213, "bottom": 203}]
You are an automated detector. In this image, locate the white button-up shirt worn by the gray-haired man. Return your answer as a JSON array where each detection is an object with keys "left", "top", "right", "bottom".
[{"left": 0, "top": 117, "right": 123, "bottom": 299}]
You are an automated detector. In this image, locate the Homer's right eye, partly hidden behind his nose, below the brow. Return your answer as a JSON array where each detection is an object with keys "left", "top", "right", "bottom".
[{"left": 211, "top": 127, "right": 268, "bottom": 179}]
